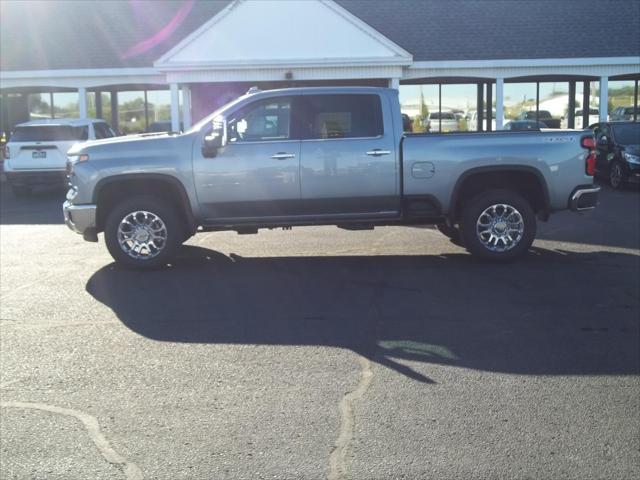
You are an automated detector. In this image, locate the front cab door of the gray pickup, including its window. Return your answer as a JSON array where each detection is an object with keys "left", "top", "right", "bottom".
[{"left": 193, "top": 96, "right": 300, "bottom": 224}]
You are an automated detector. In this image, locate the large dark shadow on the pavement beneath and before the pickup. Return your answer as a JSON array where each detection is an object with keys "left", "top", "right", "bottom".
[{"left": 86, "top": 246, "right": 640, "bottom": 383}]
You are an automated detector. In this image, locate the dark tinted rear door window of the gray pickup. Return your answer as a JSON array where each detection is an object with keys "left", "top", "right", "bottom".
[{"left": 300, "top": 94, "right": 383, "bottom": 139}]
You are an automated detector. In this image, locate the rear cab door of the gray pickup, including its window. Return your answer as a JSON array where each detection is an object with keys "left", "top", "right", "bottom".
[{"left": 299, "top": 93, "right": 400, "bottom": 218}]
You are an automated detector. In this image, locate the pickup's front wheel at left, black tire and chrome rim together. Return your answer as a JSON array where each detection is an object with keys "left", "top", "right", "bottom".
[{"left": 104, "top": 195, "right": 185, "bottom": 269}]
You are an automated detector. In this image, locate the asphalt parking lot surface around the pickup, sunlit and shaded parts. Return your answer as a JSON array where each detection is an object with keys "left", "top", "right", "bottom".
[{"left": 0, "top": 184, "right": 640, "bottom": 480}]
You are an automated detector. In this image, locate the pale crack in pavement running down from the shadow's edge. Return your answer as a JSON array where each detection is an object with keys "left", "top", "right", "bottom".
[{"left": 327, "top": 355, "right": 373, "bottom": 480}]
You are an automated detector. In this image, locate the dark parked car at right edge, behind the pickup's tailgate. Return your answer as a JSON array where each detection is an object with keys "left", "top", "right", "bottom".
[{"left": 589, "top": 122, "right": 640, "bottom": 188}]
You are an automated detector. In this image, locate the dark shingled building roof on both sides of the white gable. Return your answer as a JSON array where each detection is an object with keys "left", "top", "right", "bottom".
[{"left": 0, "top": 0, "right": 640, "bottom": 71}]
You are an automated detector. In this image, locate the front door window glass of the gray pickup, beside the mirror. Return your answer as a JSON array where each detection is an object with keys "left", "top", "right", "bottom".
[{"left": 227, "top": 97, "right": 291, "bottom": 143}]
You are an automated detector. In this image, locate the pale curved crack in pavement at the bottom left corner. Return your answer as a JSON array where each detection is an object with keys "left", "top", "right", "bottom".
[{"left": 0, "top": 402, "right": 143, "bottom": 480}]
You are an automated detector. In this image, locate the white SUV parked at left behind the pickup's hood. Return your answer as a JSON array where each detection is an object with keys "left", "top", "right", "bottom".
[{"left": 4, "top": 118, "right": 116, "bottom": 196}]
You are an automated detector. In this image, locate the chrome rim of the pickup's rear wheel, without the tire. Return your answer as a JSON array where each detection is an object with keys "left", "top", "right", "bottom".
[{"left": 476, "top": 203, "right": 524, "bottom": 252}]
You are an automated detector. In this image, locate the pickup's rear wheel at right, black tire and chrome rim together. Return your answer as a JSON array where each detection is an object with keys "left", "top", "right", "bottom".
[{"left": 461, "top": 190, "right": 536, "bottom": 261}]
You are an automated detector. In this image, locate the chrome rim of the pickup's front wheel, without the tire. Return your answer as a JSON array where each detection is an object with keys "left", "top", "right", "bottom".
[{"left": 118, "top": 210, "right": 167, "bottom": 260}]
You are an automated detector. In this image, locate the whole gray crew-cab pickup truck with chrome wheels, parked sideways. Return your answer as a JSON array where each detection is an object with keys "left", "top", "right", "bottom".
[{"left": 63, "top": 87, "right": 599, "bottom": 268}]
